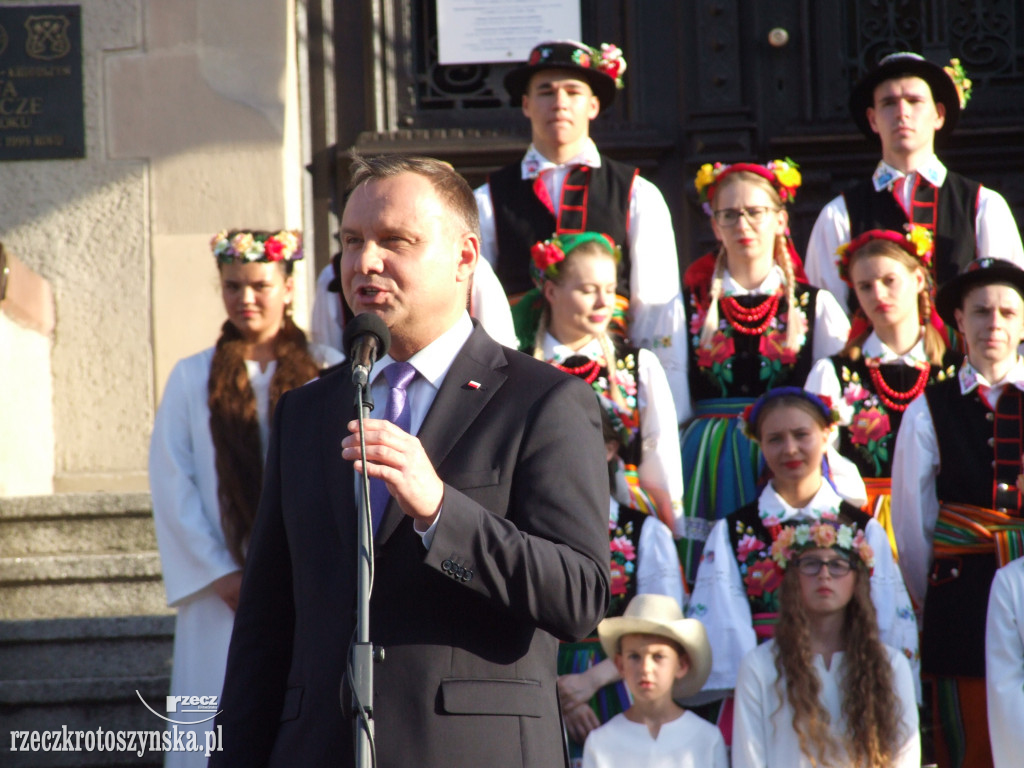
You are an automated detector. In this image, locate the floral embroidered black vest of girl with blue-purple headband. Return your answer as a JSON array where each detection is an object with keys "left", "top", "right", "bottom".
[{"left": 716, "top": 502, "right": 870, "bottom": 643}]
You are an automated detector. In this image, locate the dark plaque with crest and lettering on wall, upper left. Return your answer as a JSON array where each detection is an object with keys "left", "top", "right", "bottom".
[{"left": 0, "top": 5, "right": 85, "bottom": 161}]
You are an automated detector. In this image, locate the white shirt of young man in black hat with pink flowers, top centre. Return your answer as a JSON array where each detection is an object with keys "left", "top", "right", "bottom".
[{"left": 474, "top": 139, "right": 686, "bottom": 415}]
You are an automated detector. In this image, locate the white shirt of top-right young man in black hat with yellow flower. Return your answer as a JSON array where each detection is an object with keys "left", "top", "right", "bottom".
[{"left": 804, "top": 155, "right": 1024, "bottom": 307}]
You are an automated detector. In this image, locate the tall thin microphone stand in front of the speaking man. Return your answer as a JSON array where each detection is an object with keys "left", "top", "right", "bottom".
[{"left": 348, "top": 378, "right": 377, "bottom": 768}]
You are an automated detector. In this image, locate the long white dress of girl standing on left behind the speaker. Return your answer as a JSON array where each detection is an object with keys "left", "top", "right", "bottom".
[{"left": 150, "top": 347, "right": 341, "bottom": 768}]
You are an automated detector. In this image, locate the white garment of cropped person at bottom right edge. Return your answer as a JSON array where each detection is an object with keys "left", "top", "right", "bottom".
[{"left": 985, "top": 557, "right": 1024, "bottom": 768}]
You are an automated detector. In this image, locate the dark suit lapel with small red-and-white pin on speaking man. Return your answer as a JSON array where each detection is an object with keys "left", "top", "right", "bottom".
[{"left": 375, "top": 327, "right": 506, "bottom": 545}]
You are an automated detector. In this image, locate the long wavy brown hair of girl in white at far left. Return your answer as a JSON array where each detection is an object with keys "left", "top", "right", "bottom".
[{"left": 207, "top": 312, "right": 318, "bottom": 565}]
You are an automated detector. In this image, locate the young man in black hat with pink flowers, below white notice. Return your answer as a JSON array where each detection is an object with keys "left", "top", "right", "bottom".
[{"left": 476, "top": 41, "right": 686, "bottom": 415}]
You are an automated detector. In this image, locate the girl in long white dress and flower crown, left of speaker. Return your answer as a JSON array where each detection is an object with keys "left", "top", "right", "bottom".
[{"left": 150, "top": 229, "right": 342, "bottom": 767}]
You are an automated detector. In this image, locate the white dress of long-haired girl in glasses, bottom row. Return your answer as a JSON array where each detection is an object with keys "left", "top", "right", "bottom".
[{"left": 732, "top": 640, "right": 921, "bottom": 768}]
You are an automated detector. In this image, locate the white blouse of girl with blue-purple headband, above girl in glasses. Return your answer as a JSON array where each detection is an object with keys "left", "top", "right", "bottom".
[{"left": 687, "top": 482, "right": 920, "bottom": 691}]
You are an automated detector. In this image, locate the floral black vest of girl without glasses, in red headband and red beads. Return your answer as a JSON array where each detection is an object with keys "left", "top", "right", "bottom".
[{"left": 829, "top": 350, "right": 961, "bottom": 477}]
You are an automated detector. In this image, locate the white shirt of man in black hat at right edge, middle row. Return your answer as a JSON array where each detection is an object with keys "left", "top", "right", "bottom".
[{"left": 892, "top": 357, "right": 1024, "bottom": 607}]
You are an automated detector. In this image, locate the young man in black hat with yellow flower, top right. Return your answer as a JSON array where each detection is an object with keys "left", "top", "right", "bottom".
[{"left": 806, "top": 52, "right": 1024, "bottom": 311}]
